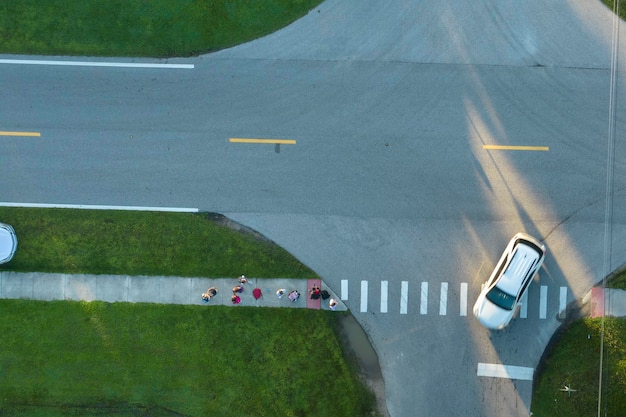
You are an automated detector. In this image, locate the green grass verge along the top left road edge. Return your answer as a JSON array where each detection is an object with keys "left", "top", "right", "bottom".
[{"left": 0, "top": 0, "right": 321, "bottom": 57}]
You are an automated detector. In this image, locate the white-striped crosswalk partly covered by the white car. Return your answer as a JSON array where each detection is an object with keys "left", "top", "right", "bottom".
[{"left": 340, "top": 279, "right": 568, "bottom": 320}]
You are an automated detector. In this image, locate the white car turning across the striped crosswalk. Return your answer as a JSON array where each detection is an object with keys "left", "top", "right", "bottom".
[{"left": 474, "top": 233, "right": 546, "bottom": 330}]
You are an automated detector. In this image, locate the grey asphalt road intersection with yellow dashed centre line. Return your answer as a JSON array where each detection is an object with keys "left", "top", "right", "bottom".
[{"left": 0, "top": 0, "right": 626, "bottom": 417}]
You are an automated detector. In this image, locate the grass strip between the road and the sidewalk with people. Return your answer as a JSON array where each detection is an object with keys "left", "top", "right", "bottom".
[{"left": 0, "top": 207, "right": 316, "bottom": 278}]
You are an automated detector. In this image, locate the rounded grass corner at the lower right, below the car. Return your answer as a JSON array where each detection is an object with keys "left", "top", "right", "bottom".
[{"left": 531, "top": 318, "right": 626, "bottom": 417}]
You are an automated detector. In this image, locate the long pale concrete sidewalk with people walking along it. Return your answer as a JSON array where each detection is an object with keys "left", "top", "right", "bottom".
[{"left": 0, "top": 271, "right": 347, "bottom": 311}]
